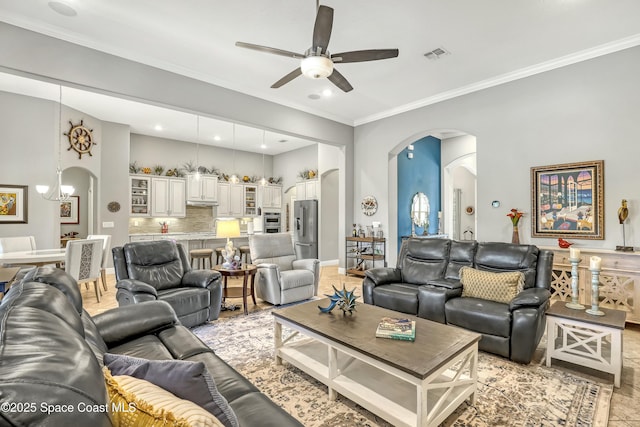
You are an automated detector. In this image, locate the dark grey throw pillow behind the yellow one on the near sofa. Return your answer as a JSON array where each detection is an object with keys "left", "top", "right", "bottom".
[{"left": 104, "top": 353, "right": 239, "bottom": 427}]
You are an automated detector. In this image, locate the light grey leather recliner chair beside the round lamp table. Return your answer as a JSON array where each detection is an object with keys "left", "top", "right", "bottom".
[{"left": 249, "top": 233, "right": 320, "bottom": 305}]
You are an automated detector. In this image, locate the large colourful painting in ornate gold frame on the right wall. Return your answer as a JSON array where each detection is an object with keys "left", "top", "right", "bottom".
[{"left": 531, "top": 160, "right": 604, "bottom": 239}]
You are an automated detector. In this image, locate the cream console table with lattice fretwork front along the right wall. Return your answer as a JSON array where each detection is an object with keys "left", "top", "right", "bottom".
[{"left": 540, "top": 246, "right": 640, "bottom": 323}]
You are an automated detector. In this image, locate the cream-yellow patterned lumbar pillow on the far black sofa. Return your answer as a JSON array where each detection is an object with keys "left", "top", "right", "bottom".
[{"left": 460, "top": 267, "right": 524, "bottom": 304}]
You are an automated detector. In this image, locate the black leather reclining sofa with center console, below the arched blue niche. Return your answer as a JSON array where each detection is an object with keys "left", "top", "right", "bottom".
[{"left": 363, "top": 238, "right": 553, "bottom": 363}]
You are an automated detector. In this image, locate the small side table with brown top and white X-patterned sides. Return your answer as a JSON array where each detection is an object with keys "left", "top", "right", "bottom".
[{"left": 546, "top": 301, "right": 627, "bottom": 387}]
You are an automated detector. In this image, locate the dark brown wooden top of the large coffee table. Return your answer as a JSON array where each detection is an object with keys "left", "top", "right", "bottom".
[{"left": 272, "top": 298, "right": 480, "bottom": 379}]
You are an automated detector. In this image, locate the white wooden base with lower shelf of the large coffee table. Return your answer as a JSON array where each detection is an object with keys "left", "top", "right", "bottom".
[{"left": 274, "top": 317, "right": 478, "bottom": 427}]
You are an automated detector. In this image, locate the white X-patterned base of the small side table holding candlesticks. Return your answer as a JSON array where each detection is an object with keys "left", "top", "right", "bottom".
[{"left": 546, "top": 315, "right": 623, "bottom": 387}]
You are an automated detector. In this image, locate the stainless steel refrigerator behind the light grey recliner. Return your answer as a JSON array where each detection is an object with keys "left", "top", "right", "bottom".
[{"left": 293, "top": 200, "right": 318, "bottom": 259}]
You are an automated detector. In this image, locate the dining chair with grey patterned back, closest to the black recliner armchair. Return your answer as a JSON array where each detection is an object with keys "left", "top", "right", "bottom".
[{"left": 64, "top": 239, "right": 104, "bottom": 302}]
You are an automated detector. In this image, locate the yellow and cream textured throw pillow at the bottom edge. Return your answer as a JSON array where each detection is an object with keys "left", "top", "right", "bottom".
[{"left": 103, "top": 368, "right": 224, "bottom": 427}]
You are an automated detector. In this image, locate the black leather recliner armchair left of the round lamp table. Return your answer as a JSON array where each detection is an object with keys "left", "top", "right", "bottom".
[{"left": 112, "top": 240, "right": 222, "bottom": 327}]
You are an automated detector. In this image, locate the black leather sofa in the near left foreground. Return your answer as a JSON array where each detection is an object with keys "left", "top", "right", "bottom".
[{"left": 0, "top": 267, "right": 302, "bottom": 427}]
